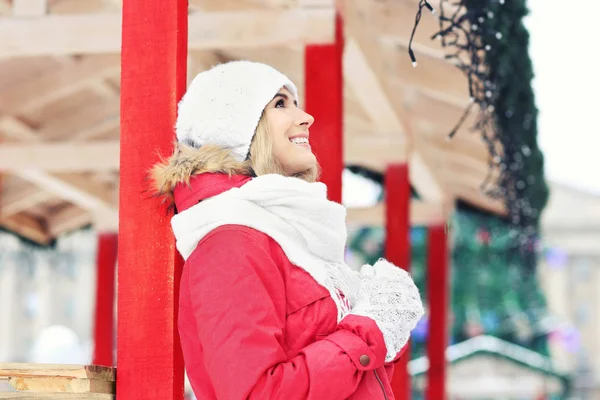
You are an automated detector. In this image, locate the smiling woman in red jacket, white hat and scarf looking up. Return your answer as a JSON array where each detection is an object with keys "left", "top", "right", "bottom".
[{"left": 152, "top": 61, "right": 423, "bottom": 400}]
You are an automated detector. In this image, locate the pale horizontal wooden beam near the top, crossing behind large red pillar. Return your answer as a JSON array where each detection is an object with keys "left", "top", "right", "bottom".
[{"left": 0, "top": 8, "right": 335, "bottom": 58}]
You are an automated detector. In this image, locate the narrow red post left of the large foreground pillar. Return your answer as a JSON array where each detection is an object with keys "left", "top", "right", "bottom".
[{"left": 92, "top": 232, "right": 117, "bottom": 367}]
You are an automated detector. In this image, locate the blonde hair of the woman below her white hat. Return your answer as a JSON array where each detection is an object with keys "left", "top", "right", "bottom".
[{"left": 248, "top": 112, "right": 320, "bottom": 182}]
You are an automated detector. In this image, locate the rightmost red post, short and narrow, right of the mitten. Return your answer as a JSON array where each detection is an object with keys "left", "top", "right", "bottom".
[{"left": 425, "top": 225, "right": 450, "bottom": 400}]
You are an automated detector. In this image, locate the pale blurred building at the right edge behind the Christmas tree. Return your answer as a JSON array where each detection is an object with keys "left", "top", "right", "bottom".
[{"left": 538, "top": 184, "right": 600, "bottom": 399}]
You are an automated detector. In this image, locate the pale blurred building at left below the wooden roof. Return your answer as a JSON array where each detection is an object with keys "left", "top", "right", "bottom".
[{"left": 0, "top": 230, "right": 96, "bottom": 363}]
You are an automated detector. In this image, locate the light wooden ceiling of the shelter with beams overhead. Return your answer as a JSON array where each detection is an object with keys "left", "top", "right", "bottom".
[{"left": 0, "top": 0, "right": 504, "bottom": 243}]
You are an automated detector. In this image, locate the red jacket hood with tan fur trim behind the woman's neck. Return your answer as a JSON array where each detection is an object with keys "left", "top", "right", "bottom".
[{"left": 150, "top": 143, "right": 253, "bottom": 212}]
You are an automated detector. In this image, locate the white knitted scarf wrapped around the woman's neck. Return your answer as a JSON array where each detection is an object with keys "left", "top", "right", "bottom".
[{"left": 171, "top": 175, "right": 359, "bottom": 321}]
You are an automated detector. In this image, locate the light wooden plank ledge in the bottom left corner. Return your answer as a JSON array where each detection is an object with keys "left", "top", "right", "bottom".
[{"left": 0, "top": 363, "right": 116, "bottom": 400}]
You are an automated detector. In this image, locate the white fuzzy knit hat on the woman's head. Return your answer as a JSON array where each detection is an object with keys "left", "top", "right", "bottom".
[{"left": 175, "top": 61, "right": 298, "bottom": 161}]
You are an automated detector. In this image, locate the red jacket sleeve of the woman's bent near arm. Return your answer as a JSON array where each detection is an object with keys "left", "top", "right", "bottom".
[{"left": 183, "top": 227, "right": 386, "bottom": 400}]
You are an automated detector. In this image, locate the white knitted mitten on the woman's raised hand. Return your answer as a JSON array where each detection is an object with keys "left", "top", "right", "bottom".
[{"left": 350, "top": 259, "right": 424, "bottom": 362}]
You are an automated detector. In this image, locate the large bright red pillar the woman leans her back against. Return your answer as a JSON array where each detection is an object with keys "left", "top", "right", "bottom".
[{"left": 117, "top": 0, "right": 188, "bottom": 400}]
